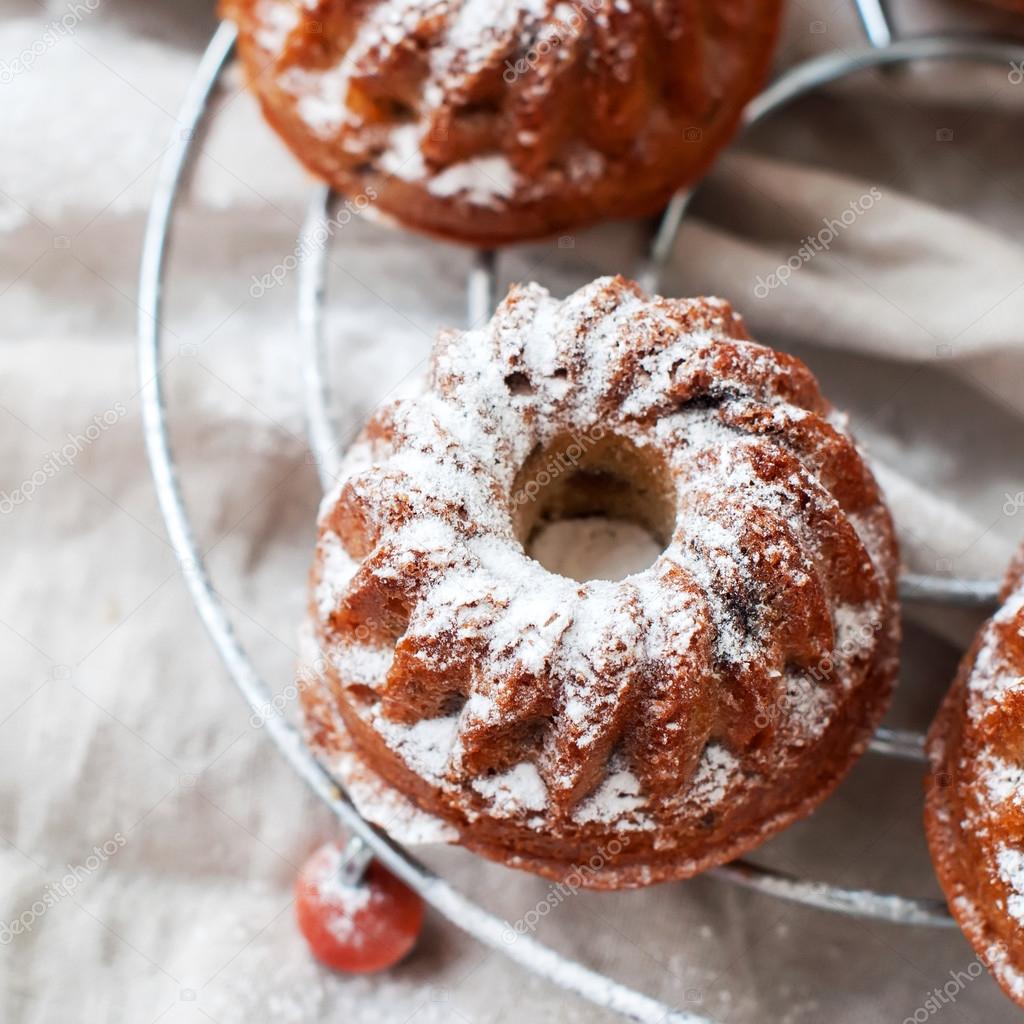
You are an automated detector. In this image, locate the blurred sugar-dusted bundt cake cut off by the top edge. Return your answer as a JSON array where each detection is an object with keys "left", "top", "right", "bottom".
[{"left": 221, "top": 0, "right": 781, "bottom": 244}]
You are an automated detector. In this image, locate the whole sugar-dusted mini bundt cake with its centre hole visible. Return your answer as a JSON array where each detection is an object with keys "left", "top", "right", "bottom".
[{"left": 305, "top": 278, "right": 899, "bottom": 888}]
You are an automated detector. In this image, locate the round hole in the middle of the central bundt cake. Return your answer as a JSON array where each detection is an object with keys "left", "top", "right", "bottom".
[{"left": 512, "top": 427, "right": 676, "bottom": 582}]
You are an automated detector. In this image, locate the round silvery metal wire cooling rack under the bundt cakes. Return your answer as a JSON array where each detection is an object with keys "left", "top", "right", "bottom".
[{"left": 138, "top": 0, "right": 1024, "bottom": 1024}]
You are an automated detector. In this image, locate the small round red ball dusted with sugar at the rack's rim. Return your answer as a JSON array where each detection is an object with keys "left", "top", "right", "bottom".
[{"left": 295, "top": 843, "right": 423, "bottom": 974}]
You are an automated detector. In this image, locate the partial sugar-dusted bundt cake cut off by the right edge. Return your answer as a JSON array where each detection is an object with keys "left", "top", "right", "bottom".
[{"left": 925, "top": 549, "right": 1024, "bottom": 1006}]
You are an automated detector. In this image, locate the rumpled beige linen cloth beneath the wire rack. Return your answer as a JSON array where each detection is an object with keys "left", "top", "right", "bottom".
[{"left": 0, "top": 0, "right": 1024, "bottom": 1024}]
